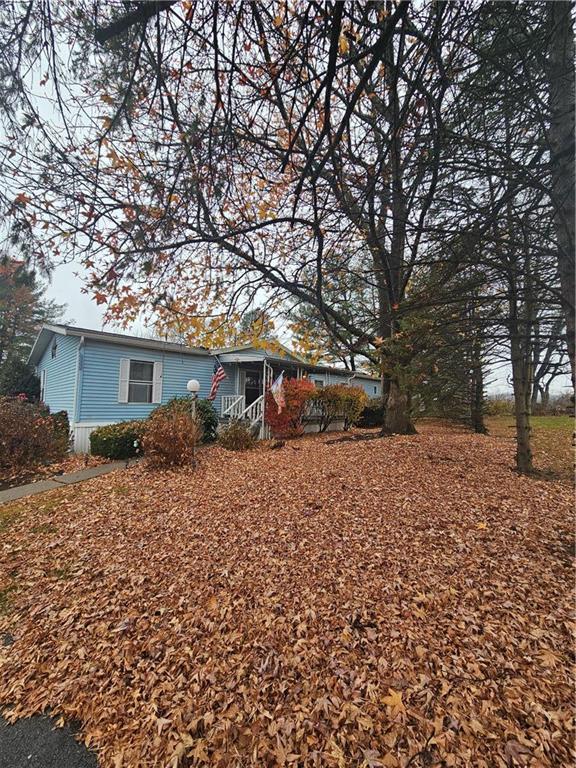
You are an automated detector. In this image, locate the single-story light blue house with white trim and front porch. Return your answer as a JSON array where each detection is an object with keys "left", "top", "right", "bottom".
[{"left": 29, "top": 325, "right": 381, "bottom": 452}]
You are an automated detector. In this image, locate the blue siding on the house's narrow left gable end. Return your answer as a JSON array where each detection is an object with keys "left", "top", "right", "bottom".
[{"left": 36, "top": 334, "right": 80, "bottom": 422}]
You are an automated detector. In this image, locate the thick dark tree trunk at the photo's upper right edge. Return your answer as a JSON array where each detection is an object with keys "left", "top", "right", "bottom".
[{"left": 546, "top": 0, "right": 576, "bottom": 387}]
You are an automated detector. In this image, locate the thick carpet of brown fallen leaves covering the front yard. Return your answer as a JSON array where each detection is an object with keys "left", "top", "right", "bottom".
[{"left": 0, "top": 429, "right": 574, "bottom": 768}]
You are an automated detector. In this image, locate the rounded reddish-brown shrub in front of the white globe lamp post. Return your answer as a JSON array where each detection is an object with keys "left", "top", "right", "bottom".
[{"left": 142, "top": 407, "right": 202, "bottom": 468}]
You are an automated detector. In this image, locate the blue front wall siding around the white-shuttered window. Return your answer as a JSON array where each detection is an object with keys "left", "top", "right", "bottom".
[{"left": 78, "top": 339, "right": 236, "bottom": 423}]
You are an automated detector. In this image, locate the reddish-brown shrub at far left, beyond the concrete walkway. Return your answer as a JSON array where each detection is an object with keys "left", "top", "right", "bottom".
[{"left": 0, "top": 395, "right": 68, "bottom": 469}]
